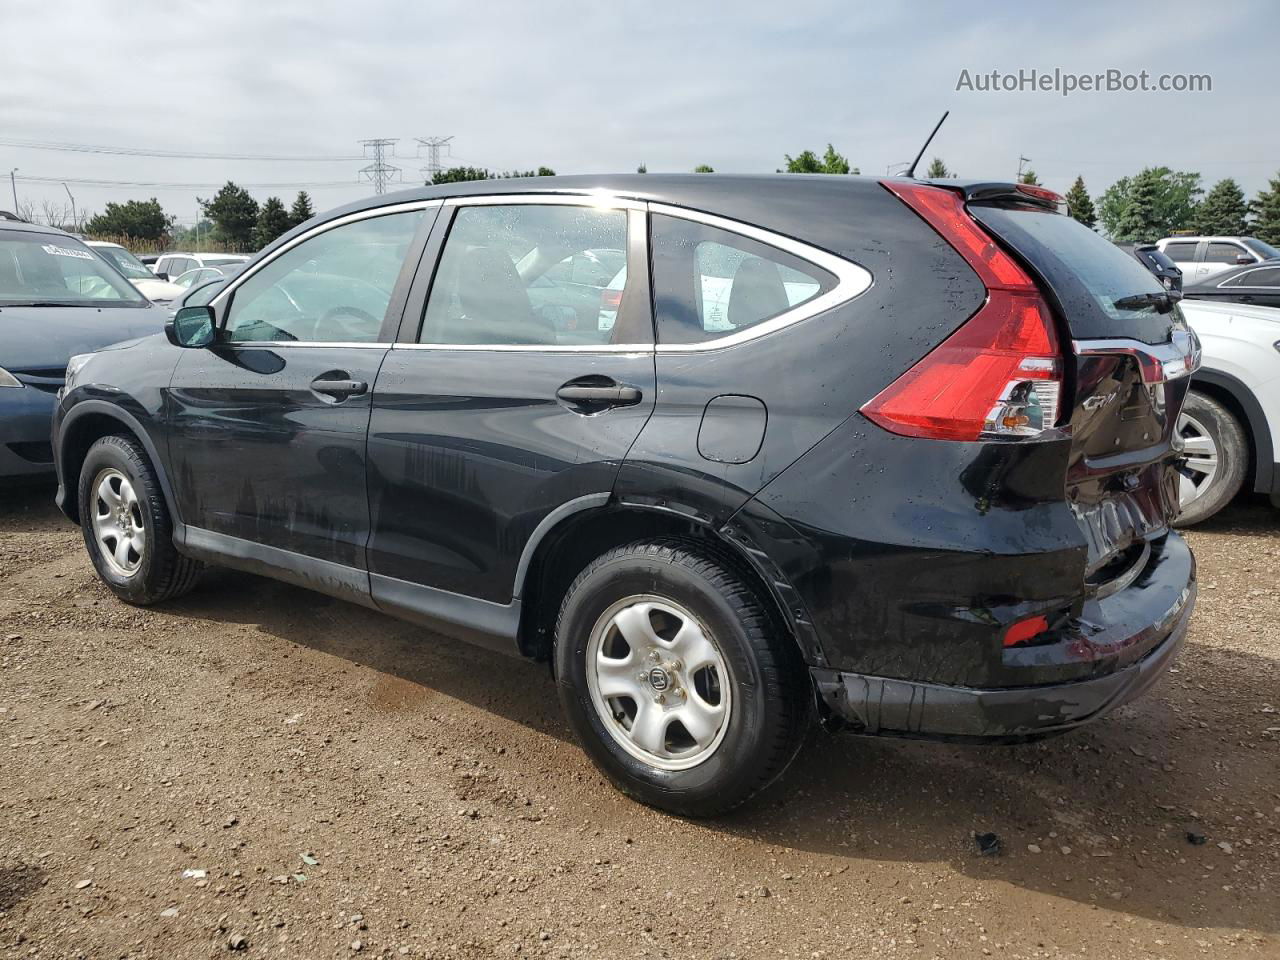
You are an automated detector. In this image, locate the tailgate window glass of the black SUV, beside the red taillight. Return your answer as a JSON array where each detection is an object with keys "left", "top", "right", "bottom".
[{"left": 970, "top": 205, "right": 1171, "bottom": 343}]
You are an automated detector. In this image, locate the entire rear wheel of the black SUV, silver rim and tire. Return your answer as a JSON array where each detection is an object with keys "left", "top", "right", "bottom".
[{"left": 554, "top": 540, "right": 812, "bottom": 817}]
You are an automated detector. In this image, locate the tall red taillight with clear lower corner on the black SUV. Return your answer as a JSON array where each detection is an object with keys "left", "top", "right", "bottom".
[{"left": 861, "top": 182, "right": 1062, "bottom": 440}]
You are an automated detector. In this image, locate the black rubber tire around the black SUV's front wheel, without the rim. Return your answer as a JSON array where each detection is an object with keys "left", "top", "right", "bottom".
[{"left": 77, "top": 435, "right": 202, "bottom": 607}]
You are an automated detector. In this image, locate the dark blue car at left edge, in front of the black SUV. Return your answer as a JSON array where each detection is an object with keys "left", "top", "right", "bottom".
[{"left": 0, "top": 220, "right": 164, "bottom": 480}]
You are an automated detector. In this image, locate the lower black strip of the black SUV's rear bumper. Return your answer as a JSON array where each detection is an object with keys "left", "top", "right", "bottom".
[{"left": 810, "top": 548, "right": 1196, "bottom": 741}]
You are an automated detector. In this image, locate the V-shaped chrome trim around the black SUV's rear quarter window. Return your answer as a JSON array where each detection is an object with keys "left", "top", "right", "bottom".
[{"left": 649, "top": 204, "right": 874, "bottom": 353}]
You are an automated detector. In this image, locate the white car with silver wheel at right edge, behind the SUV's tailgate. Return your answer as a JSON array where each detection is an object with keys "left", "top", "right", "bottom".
[{"left": 1178, "top": 300, "right": 1280, "bottom": 526}]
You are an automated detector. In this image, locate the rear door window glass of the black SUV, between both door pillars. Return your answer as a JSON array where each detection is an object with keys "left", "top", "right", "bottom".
[{"left": 419, "top": 204, "right": 636, "bottom": 347}]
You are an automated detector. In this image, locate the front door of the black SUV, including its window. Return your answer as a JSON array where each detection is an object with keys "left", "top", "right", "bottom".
[{"left": 169, "top": 205, "right": 436, "bottom": 585}]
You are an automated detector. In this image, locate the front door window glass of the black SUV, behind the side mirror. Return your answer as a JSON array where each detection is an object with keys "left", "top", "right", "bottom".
[{"left": 224, "top": 210, "right": 422, "bottom": 343}]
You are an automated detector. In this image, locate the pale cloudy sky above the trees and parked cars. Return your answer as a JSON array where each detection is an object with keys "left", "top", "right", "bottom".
[{"left": 0, "top": 0, "right": 1280, "bottom": 223}]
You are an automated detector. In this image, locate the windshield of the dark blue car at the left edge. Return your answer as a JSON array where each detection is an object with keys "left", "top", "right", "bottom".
[{"left": 0, "top": 230, "right": 147, "bottom": 307}]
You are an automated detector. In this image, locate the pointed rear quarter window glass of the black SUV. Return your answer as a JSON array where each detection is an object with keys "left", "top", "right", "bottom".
[{"left": 649, "top": 214, "right": 836, "bottom": 343}]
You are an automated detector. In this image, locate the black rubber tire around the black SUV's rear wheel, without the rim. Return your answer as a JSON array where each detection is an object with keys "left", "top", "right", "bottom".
[{"left": 554, "top": 539, "right": 812, "bottom": 817}]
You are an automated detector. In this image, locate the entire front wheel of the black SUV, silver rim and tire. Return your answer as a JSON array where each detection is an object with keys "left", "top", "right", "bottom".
[{"left": 77, "top": 435, "right": 201, "bottom": 607}]
